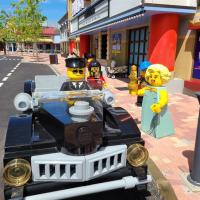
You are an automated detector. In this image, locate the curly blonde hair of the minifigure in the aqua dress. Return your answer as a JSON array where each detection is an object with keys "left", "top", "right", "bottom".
[{"left": 145, "top": 64, "right": 171, "bottom": 84}]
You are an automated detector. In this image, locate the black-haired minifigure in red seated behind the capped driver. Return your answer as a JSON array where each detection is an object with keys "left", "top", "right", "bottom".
[{"left": 87, "top": 60, "right": 107, "bottom": 89}]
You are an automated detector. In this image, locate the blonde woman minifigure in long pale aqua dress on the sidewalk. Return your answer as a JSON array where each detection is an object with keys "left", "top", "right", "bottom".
[{"left": 138, "top": 64, "right": 174, "bottom": 138}]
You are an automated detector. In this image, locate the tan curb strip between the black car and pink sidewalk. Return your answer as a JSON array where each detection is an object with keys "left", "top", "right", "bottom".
[{"left": 147, "top": 159, "right": 178, "bottom": 200}]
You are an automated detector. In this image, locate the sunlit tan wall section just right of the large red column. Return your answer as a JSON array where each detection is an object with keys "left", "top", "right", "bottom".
[{"left": 174, "top": 16, "right": 195, "bottom": 80}]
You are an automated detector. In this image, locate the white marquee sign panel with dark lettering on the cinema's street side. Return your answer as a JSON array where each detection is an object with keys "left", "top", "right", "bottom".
[{"left": 79, "top": 0, "right": 108, "bottom": 28}]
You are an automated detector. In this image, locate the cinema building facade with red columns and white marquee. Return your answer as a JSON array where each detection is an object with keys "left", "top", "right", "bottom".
[{"left": 68, "top": 0, "right": 200, "bottom": 89}]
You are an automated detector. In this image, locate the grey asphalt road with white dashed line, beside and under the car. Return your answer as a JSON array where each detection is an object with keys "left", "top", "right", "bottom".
[{"left": 0, "top": 56, "right": 159, "bottom": 200}]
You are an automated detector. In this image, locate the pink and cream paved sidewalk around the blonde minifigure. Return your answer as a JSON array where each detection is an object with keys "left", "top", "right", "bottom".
[{"left": 2, "top": 54, "right": 200, "bottom": 200}]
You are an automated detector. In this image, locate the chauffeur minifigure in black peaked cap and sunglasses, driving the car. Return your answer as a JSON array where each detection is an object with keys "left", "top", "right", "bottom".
[{"left": 61, "top": 58, "right": 89, "bottom": 91}]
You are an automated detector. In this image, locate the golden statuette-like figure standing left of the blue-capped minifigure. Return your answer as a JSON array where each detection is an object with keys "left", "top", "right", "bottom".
[{"left": 128, "top": 65, "right": 138, "bottom": 95}]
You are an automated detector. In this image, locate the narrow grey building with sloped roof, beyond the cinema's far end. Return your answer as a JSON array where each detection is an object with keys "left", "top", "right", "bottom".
[{"left": 58, "top": 13, "right": 69, "bottom": 54}]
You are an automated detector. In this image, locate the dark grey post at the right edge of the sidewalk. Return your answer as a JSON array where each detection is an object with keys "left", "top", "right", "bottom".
[{"left": 188, "top": 92, "right": 200, "bottom": 186}]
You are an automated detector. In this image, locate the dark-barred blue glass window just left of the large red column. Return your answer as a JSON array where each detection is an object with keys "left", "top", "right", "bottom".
[{"left": 129, "top": 27, "right": 149, "bottom": 66}]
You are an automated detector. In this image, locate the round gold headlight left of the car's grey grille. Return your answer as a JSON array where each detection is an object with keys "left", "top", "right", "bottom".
[{"left": 3, "top": 159, "right": 31, "bottom": 187}]
